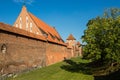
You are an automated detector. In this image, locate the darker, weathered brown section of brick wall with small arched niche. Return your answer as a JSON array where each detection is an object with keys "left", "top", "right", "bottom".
[{"left": 0, "top": 31, "right": 46, "bottom": 73}]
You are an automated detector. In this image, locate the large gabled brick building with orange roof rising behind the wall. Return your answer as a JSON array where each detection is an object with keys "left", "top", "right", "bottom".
[{"left": 13, "top": 6, "right": 64, "bottom": 44}]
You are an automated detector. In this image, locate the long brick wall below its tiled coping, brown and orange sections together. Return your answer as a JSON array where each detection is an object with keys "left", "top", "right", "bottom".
[{"left": 0, "top": 30, "right": 71, "bottom": 74}]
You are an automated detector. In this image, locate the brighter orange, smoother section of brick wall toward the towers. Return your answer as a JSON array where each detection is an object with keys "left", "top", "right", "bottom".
[{"left": 46, "top": 43, "right": 66, "bottom": 65}]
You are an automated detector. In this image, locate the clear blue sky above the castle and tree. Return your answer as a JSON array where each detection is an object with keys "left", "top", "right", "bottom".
[{"left": 0, "top": 0, "right": 120, "bottom": 42}]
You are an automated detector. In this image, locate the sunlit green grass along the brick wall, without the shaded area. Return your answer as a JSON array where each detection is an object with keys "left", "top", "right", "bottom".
[{"left": 7, "top": 58, "right": 94, "bottom": 80}]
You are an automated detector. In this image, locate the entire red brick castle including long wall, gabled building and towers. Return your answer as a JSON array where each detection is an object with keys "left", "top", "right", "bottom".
[{"left": 0, "top": 6, "right": 81, "bottom": 75}]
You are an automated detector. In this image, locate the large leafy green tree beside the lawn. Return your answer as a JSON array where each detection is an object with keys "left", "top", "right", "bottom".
[{"left": 82, "top": 8, "right": 120, "bottom": 63}]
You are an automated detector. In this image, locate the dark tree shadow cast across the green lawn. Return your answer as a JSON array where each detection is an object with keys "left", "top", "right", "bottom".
[{"left": 61, "top": 60, "right": 120, "bottom": 80}]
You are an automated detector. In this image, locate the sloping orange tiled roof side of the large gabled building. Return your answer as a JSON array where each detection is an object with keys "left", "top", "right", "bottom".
[{"left": 28, "top": 12, "right": 64, "bottom": 43}]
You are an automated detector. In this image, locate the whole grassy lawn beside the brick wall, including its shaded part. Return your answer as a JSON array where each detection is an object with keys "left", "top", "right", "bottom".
[{"left": 7, "top": 57, "right": 120, "bottom": 80}]
